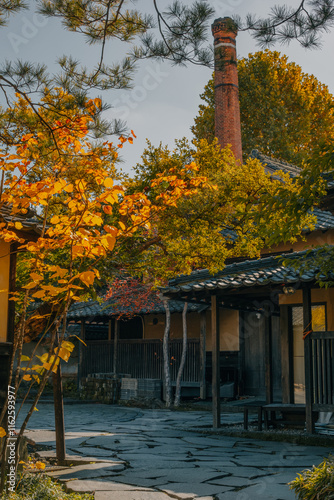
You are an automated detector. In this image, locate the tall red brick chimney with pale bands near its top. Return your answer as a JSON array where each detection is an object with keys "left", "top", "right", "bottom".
[{"left": 212, "top": 17, "right": 242, "bottom": 161}]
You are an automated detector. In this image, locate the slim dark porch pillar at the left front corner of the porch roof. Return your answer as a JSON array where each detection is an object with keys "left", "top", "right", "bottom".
[{"left": 211, "top": 295, "right": 220, "bottom": 429}]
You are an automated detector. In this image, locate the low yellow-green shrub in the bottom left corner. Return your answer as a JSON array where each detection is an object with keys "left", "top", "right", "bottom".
[{"left": 0, "top": 474, "right": 94, "bottom": 500}]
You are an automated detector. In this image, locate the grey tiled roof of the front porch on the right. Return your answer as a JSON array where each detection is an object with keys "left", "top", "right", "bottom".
[{"left": 162, "top": 246, "right": 334, "bottom": 296}]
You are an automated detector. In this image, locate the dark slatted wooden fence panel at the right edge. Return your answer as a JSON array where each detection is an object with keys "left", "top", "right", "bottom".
[{"left": 310, "top": 332, "right": 334, "bottom": 411}]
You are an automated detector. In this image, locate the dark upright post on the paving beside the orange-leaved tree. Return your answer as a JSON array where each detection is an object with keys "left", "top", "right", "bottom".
[{"left": 52, "top": 363, "right": 66, "bottom": 465}]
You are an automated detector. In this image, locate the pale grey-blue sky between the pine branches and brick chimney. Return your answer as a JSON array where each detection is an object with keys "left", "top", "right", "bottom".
[{"left": 0, "top": 0, "right": 334, "bottom": 172}]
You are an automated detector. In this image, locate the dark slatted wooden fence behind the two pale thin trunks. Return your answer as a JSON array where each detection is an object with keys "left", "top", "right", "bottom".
[{"left": 79, "top": 339, "right": 201, "bottom": 382}]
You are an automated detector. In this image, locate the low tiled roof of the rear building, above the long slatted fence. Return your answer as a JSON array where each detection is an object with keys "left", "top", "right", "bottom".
[{"left": 67, "top": 300, "right": 201, "bottom": 320}]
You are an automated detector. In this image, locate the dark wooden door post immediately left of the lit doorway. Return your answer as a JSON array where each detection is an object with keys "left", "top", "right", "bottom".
[{"left": 280, "top": 305, "right": 294, "bottom": 404}]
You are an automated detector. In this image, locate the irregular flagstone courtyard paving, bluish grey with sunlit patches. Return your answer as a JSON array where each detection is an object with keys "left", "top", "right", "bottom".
[{"left": 18, "top": 404, "right": 332, "bottom": 500}]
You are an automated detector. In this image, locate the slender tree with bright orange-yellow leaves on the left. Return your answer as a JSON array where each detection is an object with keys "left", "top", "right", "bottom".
[{"left": 0, "top": 89, "right": 213, "bottom": 480}]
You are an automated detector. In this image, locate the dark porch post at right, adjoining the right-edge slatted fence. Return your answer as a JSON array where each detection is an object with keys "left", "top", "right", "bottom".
[{"left": 303, "top": 285, "right": 314, "bottom": 434}]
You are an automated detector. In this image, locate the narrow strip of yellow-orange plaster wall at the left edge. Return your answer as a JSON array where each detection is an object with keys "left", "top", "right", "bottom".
[{"left": 0, "top": 240, "right": 10, "bottom": 342}]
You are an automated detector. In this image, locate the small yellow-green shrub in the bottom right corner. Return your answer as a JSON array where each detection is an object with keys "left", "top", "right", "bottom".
[{"left": 289, "top": 457, "right": 334, "bottom": 500}]
